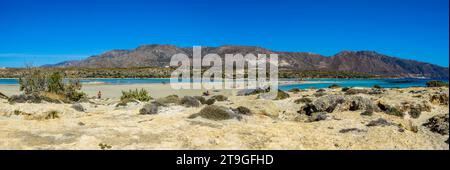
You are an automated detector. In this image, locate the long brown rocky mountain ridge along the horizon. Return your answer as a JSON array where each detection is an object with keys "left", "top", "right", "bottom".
[{"left": 45, "top": 45, "right": 449, "bottom": 78}]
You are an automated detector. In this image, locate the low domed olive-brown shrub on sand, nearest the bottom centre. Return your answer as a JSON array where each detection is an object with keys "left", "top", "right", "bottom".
[{"left": 189, "top": 105, "right": 242, "bottom": 121}]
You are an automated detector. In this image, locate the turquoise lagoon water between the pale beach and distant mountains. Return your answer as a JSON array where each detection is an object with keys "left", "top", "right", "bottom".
[{"left": 0, "top": 78, "right": 448, "bottom": 90}]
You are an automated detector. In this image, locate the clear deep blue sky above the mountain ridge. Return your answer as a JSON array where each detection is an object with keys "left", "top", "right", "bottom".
[{"left": 0, "top": 0, "right": 449, "bottom": 67}]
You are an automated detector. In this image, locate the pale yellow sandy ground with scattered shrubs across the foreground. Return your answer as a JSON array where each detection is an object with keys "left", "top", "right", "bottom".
[{"left": 0, "top": 84, "right": 449, "bottom": 150}]
